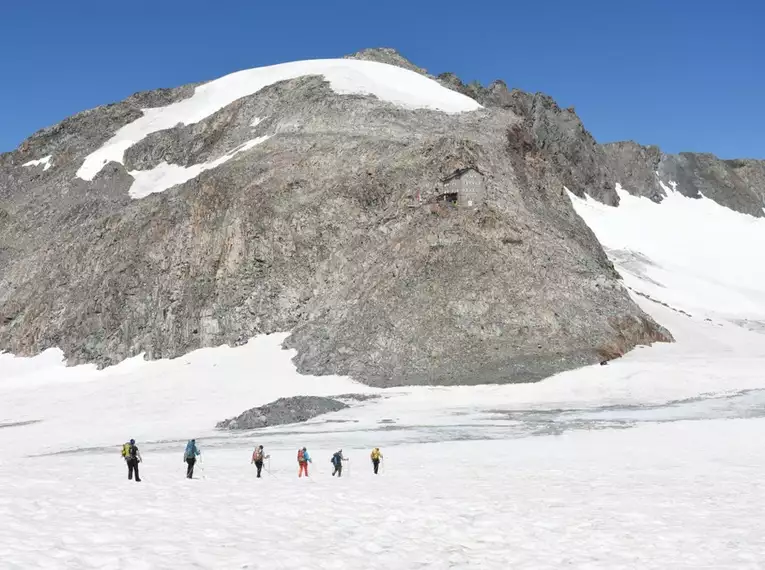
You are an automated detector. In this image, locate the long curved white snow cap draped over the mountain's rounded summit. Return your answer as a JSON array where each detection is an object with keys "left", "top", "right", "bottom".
[{"left": 77, "top": 59, "right": 481, "bottom": 180}]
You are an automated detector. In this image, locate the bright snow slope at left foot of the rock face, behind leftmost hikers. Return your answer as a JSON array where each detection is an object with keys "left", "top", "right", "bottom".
[{"left": 0, "top": 334, "right": 368, "bottom": 457}]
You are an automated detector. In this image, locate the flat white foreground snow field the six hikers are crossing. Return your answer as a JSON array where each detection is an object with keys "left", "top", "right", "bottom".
[{"left": 0, "top": 420, "right": 765, "bottom": 570}]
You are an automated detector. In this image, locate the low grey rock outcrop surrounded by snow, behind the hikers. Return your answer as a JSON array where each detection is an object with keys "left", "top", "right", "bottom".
[{"left": 215, "top": 396, "right": 348, "bottom": 430}]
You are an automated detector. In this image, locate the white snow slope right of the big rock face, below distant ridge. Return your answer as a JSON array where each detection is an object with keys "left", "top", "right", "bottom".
[{"left": 569, "top": 182, "right": 765, "bottom": 322}]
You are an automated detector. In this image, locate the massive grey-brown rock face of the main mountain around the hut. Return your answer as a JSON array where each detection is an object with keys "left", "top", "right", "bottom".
[{"left": 0, "top": 51, "right": 672, "bottom": 386}]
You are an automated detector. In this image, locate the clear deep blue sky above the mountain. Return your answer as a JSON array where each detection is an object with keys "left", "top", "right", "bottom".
[{"left": 0, "top": 0, "right": 765, "bottom": 158}]
